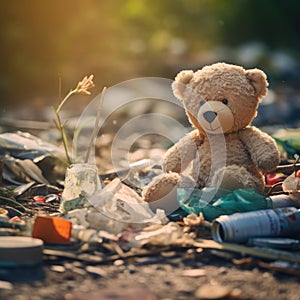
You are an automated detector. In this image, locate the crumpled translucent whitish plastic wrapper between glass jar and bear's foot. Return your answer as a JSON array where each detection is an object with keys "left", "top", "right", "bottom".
[{"left": 68, "top": 178, "right": 167, "bottom": 234}]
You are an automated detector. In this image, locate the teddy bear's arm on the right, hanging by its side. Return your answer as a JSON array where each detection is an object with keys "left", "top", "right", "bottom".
[{"left": 239, "top": 126, "right": 280, "bottom": 173}]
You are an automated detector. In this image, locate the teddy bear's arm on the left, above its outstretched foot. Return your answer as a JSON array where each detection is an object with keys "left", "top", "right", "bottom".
[{"left": 163, "top": 129, "right": 202, "bottom": 173}]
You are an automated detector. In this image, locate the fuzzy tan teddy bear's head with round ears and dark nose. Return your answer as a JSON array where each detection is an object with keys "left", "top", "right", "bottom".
[{"left": 172, "top": 63, "right": 268, "bottom": 134}]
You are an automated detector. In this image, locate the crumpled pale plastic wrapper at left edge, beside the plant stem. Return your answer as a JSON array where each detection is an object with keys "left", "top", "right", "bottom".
[{"left": 0, "top": 131, "right": 66, "bottom": 185}]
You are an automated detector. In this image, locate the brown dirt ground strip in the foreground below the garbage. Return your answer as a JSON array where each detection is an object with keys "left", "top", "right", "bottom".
[{"left": 0, "top": 239, "right": 300, "bottom": 300}]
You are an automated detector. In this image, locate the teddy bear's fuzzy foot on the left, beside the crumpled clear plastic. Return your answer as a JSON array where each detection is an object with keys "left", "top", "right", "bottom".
[{"left": 142, "top": 172, "right": 180, "bottom": 202}]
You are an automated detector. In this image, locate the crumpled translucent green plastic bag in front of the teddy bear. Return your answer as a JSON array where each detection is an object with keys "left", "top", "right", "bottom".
[{"left": 177, "top": 188, "right": 272, "bottom": 221}]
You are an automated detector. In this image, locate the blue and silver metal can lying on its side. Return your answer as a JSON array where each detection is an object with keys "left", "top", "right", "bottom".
[{"left": 212, "top": 207, "right": 300, "bottom": 243}]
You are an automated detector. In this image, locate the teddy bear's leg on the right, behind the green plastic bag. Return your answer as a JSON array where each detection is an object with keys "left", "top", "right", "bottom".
[{"left": 211, "top": 165, "right": 264, "bottom": 192}]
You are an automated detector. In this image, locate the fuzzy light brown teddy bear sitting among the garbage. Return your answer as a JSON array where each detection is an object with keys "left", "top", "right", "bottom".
[{"left": 143, "top": 63, "right": 280, "bottom": 210}]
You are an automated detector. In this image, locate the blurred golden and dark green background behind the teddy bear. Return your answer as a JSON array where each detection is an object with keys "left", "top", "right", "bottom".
[{"left": 0, "top": 0, "right": 300, "bottom": 126}]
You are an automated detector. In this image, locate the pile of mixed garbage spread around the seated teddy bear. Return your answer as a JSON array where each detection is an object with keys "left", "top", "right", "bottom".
[{"left": 0, "top": 131, "right": 300, "bottom": 275}]
